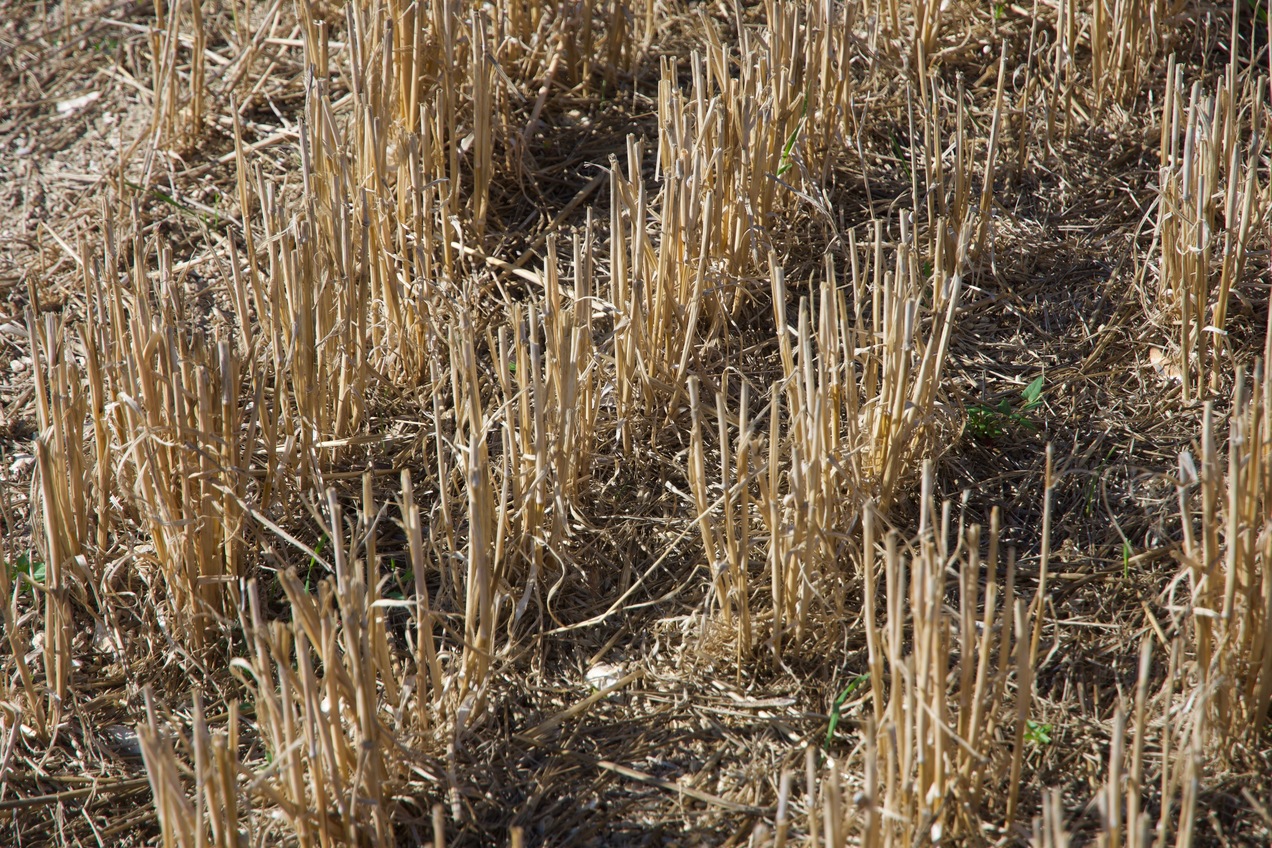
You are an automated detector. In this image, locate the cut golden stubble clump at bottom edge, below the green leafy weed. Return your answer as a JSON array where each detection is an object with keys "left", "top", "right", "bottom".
[{"left": 808, "top": 493, "right": 1032, "bottom": 848}]
